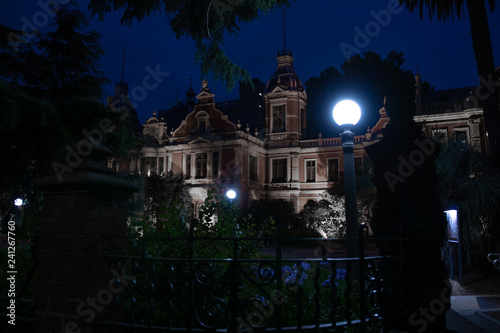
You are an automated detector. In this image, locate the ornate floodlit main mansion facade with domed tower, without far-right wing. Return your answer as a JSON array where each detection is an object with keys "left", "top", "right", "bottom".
[{"left": 129, "top": 51, "right": 389, "bottom": 211}]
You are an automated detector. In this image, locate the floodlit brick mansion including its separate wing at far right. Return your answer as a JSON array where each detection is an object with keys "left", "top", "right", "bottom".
[{"left": 110, "top": 51, "right": 492, "bottom": 212}]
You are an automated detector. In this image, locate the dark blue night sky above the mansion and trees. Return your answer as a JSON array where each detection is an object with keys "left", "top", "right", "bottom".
[{"left": 0, "top": 0, "right": 500, "bottom": 126}]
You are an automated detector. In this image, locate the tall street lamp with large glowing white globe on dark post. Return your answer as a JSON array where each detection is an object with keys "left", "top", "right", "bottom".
[{"left": 332, "top": 100, "right": 361, "bottom": 257}]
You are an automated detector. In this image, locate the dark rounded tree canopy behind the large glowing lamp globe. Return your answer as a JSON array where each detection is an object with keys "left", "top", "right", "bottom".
[{"left": 306, "top": 51, "right": 430, "bottom": 138}]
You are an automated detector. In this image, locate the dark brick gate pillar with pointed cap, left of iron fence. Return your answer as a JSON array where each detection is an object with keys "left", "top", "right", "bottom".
[{"left": 33, "top": 146, "right": 137, "bottom": 333}]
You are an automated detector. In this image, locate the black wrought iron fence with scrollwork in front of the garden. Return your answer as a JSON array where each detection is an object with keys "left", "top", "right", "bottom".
[{"left": 97, "top": 224, "right": 410, "bottom": 332}]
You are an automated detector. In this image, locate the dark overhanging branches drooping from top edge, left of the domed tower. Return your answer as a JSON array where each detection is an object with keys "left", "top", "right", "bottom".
[{"left": 89, "top": 0, "right": 291, "bottom": 89}]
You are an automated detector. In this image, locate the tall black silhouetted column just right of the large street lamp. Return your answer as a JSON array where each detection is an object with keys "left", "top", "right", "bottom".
[{"left": 366, "top": 107, "right": 451, "bottom": 333}]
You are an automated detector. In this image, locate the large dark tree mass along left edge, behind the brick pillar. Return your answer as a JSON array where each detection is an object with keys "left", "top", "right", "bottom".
[{"left": 0, "top": 2, "right": 138, "bottom": 217}]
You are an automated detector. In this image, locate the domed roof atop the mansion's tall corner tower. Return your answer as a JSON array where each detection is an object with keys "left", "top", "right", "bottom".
[{"left": 266, "top": 50, "right": 304, "bottom": 93}]
